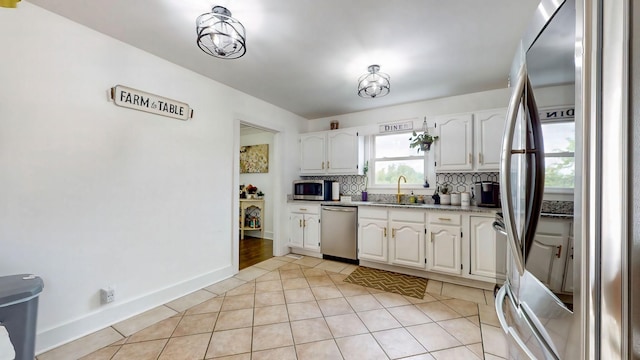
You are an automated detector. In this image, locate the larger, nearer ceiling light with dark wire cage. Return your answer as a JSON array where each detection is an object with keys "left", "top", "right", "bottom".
[{"left": 196, "top": 6, "right": 247, "bottom": 59}]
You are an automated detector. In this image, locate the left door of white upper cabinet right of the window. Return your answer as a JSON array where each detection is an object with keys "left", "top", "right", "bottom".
[{"left": 435, "top": 114, "right": 473, "bottom": 172}]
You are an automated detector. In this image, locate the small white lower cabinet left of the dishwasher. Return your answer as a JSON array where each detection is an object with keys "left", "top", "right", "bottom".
[{"left": 288, "top": 205, "right": 320, "bottom": 252}]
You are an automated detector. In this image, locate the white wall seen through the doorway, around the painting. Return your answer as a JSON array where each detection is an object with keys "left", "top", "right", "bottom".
[{"left": 240, "top": 132, "right": 275, "bottom": 239}]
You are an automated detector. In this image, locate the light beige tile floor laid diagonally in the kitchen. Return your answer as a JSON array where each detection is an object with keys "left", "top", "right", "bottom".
[{"left": 37, "top": 256, "right": 507, "bottom": 360}]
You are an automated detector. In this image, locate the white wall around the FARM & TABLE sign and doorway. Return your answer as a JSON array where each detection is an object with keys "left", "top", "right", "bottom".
[{"left": 0, "top": 1, "right": 306, "bottom": 352}]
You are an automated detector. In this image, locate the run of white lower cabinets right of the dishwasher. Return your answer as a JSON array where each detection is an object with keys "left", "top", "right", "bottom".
[{"left": 358, "top": 206, "right": 507, "bottom": 283}]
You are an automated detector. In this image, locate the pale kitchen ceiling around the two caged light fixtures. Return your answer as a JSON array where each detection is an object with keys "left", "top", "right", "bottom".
[{"left": 28, "top": 0, "right": 539, "bottom": 119}]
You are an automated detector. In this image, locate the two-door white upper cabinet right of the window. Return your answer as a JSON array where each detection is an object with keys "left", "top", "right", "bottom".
[{"left": 435, "top": 109, "right": 506, "bottom": 172}]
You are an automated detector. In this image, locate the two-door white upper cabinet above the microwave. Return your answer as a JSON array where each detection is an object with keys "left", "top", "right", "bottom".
[{"left": 300, "top": 129, "right": 364, "bottom": 175}]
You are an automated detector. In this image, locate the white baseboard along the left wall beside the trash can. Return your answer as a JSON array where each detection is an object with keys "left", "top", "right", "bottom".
[{"left": 36, "top": 266, "right": 235, "bottom": 355}]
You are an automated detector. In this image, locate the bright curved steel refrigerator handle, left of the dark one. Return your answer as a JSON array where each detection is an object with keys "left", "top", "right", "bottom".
[{"left": 500, "top": 64, "right": 527, "bottom": 276}]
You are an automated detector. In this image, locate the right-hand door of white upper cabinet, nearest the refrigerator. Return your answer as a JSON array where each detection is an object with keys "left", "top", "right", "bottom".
[{"left": 473, "top": 109, "right": 507, "bottom": 171}]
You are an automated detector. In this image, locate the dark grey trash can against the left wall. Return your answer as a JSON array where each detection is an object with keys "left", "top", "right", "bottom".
[{"left": 0, "top": 274, "right": 44, "bottom": 360}]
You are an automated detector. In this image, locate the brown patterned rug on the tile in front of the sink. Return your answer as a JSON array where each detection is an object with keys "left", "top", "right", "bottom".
[{"left": 344, "top": 266, "right": 427, "bottom": 299}]
